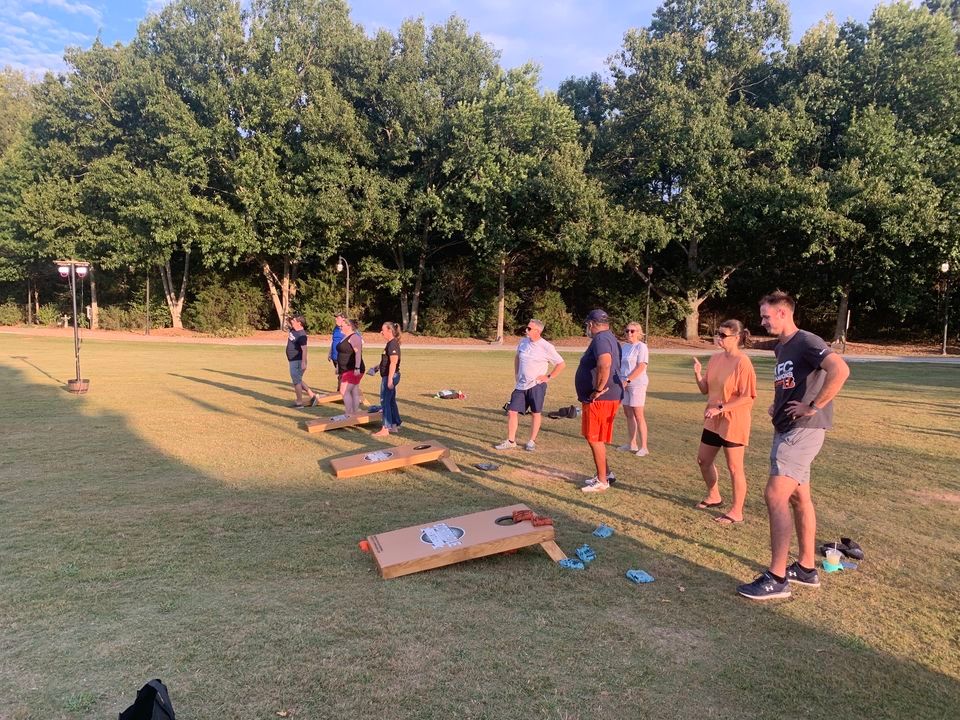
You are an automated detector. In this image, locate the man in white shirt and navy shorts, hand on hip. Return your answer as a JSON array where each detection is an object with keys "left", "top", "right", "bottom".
[{"left": 494, "top": 319, "right": 564, "bottom": 452}]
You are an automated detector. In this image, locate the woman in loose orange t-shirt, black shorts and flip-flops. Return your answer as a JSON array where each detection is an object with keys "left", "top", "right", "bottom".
[{"left": 693, "top": 320, "right": 757, "bottom": 525}]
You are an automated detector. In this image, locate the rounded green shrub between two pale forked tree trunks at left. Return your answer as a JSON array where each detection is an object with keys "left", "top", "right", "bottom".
[{"left": 183, "top": 280, "right": 266, "bottom": 337}]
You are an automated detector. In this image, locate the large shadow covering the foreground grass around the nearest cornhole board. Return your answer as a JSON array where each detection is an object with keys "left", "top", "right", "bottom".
[{"left": 0, "top": 365, "right": 960, "bottom": 720}]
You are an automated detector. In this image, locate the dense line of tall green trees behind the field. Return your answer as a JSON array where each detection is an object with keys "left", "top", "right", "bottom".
[{"left": 0, "top": 0, "right": 960, "bottom": 339}]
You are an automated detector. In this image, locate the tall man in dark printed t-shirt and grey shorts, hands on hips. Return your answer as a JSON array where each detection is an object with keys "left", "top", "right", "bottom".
[{"left": 737, "top": 290, "right": 850, "bottom": 600}]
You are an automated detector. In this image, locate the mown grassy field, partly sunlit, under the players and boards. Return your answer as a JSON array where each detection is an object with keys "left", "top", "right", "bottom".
[{"left": 0, "top": 336, "right": 960, "bottom": 720}]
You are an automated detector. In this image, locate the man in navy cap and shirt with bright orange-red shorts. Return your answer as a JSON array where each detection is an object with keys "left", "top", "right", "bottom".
[{"left": 574, "top": 309, "right": 623, "bottom": 492}]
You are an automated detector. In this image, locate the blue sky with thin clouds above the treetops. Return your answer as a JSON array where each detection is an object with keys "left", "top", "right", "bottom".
[{"left": 0, "top": 0, "right": 878, "bottom": 89}]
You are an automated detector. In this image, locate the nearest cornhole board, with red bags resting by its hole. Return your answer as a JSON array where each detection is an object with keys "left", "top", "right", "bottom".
[{"left": 367, "top": 504, "right": 567, "bottom": 580}]
